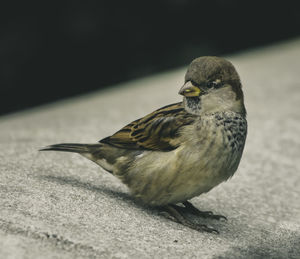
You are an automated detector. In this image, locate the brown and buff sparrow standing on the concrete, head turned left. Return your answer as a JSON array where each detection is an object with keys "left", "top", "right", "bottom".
[{"left": 40, "top": 56, "right": 247, "bottom": 233}]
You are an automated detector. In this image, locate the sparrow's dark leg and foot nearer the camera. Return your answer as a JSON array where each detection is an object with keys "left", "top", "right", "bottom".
[{"left": 161, "top": 204, "right": 219, "bottom": 234}]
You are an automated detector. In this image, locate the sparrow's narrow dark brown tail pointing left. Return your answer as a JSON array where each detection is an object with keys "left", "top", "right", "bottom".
[{"left": 39, "top": 143, "right": 101, "bottom": 153}]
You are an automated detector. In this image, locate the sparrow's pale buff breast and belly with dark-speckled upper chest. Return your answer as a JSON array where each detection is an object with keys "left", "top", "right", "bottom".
[{"left": 115, "top": 114, "right": 247, "bottom": 205}]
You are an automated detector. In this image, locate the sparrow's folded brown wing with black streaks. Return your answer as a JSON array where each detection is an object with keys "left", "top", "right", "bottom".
[{"left": 99, "top": 102, "right": 196, "bottom": 151}]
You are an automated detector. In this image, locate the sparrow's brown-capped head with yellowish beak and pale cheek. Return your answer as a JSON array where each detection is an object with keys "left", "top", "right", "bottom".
[{"left": 179, "top": 56, "right": 246, "bottom": 115}]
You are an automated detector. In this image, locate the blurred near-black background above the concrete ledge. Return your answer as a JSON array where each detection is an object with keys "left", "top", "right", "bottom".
[{"left": 0, "top": 0, "right": 300, "bottom": 114}]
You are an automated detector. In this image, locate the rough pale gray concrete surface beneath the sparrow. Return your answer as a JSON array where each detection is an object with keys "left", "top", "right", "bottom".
[{"left": 0, "top": 40, "right": 300, "bottom": 258}]
